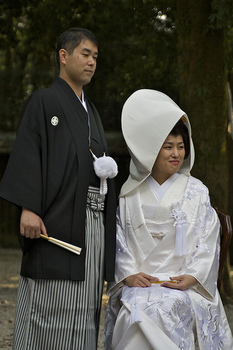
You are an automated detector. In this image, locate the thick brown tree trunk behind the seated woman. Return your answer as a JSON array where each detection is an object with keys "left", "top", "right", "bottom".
[{"left": 177, "top": 0, "right": 233, "bottom": 295}]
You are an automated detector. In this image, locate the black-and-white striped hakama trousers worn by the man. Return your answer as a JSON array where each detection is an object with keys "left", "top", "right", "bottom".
[{"left": 13, "top": 187, "right": 104, "bottom": 350}]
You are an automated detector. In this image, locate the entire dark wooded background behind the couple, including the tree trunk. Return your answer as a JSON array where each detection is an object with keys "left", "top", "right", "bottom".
[{"left": 0, "top": 0, "right": 233, "bottom": 295}]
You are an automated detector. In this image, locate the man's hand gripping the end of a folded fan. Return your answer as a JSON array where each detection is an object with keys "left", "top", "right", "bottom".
[{"left": 20, "top": 208, "right": 47, "bottom": 239}]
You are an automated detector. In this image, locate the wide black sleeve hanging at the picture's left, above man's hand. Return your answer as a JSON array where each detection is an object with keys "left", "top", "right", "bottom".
[{"left": 0, "top": 94, "right": 44, "bottom": 215}]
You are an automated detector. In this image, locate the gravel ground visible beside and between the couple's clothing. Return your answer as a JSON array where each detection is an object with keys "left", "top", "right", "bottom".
[{"left": 0, "top": 248, "right": 233, "bottom": 350}]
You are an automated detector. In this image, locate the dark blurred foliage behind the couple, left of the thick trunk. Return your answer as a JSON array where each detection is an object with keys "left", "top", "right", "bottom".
[{"left": 0, "top": 0, "right": 178, "bottom": 130}]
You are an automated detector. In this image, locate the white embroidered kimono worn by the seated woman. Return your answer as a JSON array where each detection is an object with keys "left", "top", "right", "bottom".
[{"left": 105, "top": 174, "right": 233, "bottom": 350}]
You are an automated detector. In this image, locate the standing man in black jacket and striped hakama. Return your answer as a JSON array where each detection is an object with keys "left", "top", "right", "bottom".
[{"left": 0, "top": 28, "right": 116, "bottom": 350}]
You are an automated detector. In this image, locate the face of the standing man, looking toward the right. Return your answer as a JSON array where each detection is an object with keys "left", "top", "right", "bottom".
[{"left": 60, "top": 40, "right": 98, "bottom": 86}]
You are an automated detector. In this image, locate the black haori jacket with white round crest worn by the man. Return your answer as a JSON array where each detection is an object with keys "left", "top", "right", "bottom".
[{"left": 0, "top": 77, "right": 116, "bottom": 281}]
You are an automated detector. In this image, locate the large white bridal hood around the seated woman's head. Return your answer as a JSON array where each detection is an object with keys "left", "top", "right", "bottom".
[{"left": 120, "top": 89, "right": 194, "bottom": 197}]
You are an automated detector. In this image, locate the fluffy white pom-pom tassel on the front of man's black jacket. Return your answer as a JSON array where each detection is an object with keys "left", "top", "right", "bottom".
[{"left": 90, "top": 150, "right": 118, "bottom": 195}]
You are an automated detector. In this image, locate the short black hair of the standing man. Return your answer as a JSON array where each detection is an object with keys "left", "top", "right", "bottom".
[{"left": 56, "top": 27, "right": 98, "bottom": 69}]
